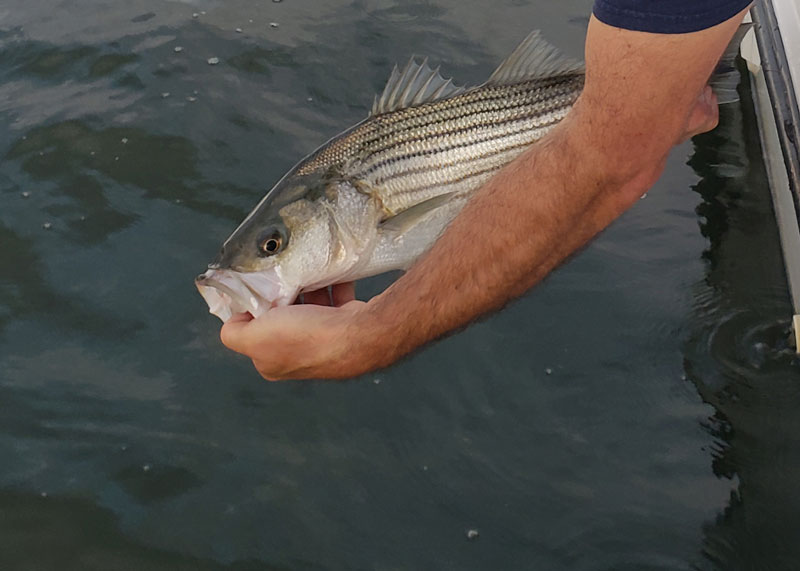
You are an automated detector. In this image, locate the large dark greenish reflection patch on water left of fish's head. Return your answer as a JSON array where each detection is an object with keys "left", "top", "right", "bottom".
[{"left": 6, "top": 121, "right": 223, "bottom": 223}]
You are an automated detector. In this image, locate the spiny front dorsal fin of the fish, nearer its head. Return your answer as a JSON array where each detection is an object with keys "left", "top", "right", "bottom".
[{"left": 372, "top": 57, "right": 464, "bottom": 115}]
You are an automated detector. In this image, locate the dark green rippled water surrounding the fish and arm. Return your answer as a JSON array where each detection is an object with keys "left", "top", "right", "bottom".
[{"left": 0, "top": 0, "right": 800, "bottom": 571}]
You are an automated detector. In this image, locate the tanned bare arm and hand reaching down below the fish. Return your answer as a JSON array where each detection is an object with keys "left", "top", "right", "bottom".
[{"left": 222, "top": 8, "right": 742, "bottom": 379}]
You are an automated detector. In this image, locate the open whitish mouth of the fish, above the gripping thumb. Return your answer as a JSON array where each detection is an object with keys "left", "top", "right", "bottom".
[{"left": 194, "top": 268, "right": 297, "bottom": 322}]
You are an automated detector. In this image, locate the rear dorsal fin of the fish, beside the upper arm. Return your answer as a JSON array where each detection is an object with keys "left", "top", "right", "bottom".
[{"left": 485, "top": 30, "right": 584, "bottom": 85}]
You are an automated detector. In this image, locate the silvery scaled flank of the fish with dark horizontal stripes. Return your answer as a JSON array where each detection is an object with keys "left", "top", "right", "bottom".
[{"left": 301, "top": 73, "right": 583, "bottom": 213}]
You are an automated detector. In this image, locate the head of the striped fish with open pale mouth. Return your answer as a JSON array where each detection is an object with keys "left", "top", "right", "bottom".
[{"left": 195, "top": 170, "right": 378, "bottom": 321}]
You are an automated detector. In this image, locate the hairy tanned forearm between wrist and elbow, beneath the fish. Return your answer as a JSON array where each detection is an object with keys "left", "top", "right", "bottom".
[{"left": 358, "top": 104, "right": 659, "bottom": 366}]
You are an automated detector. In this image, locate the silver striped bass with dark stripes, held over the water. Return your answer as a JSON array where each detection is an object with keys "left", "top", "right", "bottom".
[{"left": 195, "top": 30, "right": 585, "bottom": 322}]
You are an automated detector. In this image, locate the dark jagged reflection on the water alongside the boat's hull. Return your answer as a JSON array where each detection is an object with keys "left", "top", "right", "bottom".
[{"left": 685, "top": 67, "right": 800, "bottom": 570}]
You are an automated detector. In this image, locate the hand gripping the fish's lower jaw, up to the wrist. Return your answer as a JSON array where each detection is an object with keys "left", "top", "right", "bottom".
[{"left": 220, "top": 282, "right": 371, "bottom": 381}]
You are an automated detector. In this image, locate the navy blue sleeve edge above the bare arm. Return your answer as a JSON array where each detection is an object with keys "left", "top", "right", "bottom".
[{"left": 594, "top": 0, "right": 752, "bottom": 34}]
